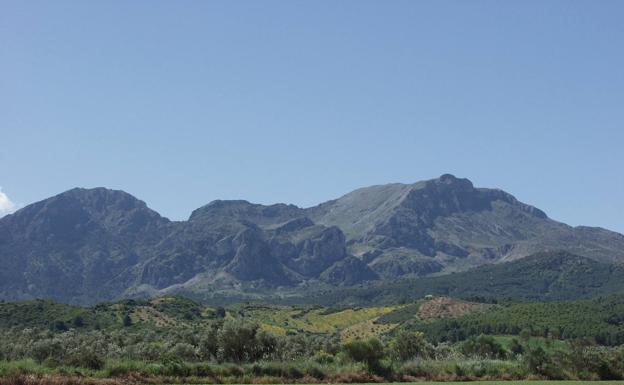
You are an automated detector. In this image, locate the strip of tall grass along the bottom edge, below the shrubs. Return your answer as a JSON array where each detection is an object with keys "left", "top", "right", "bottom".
[{"left": 0, "top": 359, "right": 624, "bottom": 385}]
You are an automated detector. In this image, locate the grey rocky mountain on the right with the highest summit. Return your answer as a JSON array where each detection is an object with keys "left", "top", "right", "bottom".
[{"left": 307, "top": 174, "right": 624, "bottom": 278}]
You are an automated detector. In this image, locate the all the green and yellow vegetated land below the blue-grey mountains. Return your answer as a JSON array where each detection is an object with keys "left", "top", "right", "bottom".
[{"left": 0, "top": 296, "right": 624, "bottom": 385}]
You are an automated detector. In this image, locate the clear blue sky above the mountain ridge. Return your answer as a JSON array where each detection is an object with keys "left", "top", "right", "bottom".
[{"left": 0, "top": 0, "right": 624, "bottom": 232}]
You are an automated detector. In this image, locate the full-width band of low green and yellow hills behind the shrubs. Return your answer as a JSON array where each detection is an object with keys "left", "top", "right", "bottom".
[{"left": 0, "top": 294, "right": 624, "bottom": 345}]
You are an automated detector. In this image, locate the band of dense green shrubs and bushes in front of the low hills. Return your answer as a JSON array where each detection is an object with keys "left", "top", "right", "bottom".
[{"left": 0, "top": 321, "right": 624, "bottom": 382}]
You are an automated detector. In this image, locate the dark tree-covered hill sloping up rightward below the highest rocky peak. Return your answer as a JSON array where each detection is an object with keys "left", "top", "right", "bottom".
[{"left": 305, "top": 252, "right": 624, "bottom": 306}]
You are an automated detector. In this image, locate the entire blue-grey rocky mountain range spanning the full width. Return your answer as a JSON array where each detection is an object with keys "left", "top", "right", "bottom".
[{"left": 0, "top": 174, "right": 624, "bottom": 304}]
